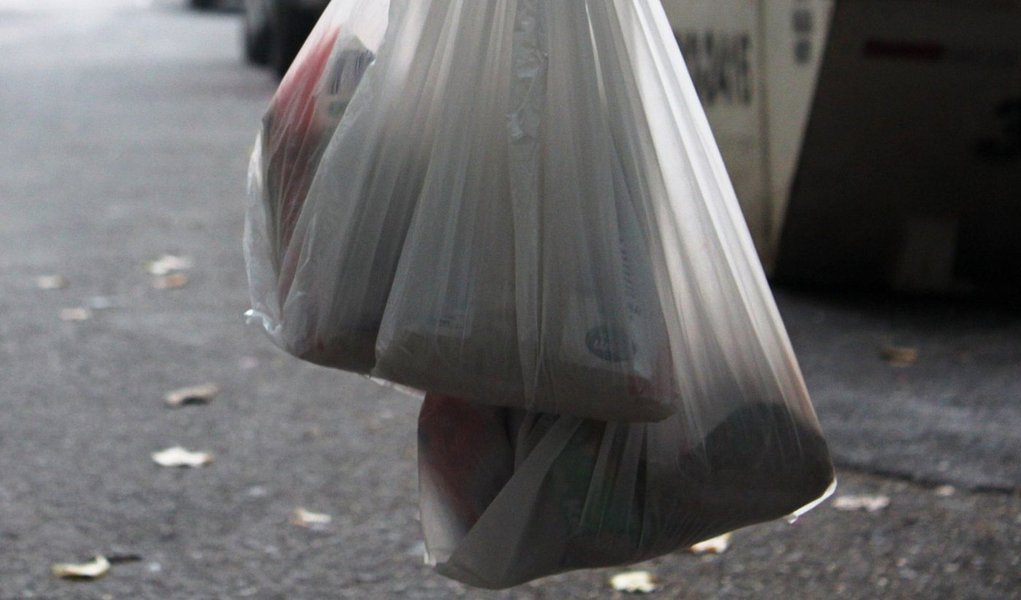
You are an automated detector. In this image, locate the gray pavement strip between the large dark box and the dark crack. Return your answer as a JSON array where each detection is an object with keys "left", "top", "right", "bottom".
[{"left": 777, "top": 290, "right": 1021, "bottom": 491}]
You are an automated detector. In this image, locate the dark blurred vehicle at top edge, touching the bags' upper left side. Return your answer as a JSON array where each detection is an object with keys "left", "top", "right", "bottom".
[{"left": 242, "top": 0, "right": 330, "bottom": 77}]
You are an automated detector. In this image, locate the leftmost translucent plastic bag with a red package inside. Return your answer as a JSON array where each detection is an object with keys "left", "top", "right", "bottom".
[{"left": 244, "top": 0, "right": 402, "bottom": 372}]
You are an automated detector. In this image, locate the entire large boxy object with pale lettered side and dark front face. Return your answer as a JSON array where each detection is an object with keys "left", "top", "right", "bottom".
[{"left": 663, "top": 0, "right": 1021, "bottom": 292}]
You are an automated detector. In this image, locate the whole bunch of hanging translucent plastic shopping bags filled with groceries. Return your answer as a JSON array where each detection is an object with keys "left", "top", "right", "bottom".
[{"left": 245, "top": 0, "right": 833, "bottom": 588}]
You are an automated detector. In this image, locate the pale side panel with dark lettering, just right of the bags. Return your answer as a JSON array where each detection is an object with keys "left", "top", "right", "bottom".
[{"left": 663, "top": 0, "right": 833, "bottom": 267}]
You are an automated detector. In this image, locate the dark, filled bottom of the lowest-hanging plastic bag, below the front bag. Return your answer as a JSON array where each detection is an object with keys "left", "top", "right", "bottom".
[{"left": 419, "top": 395, "right": 833, "bottom": 589}]
